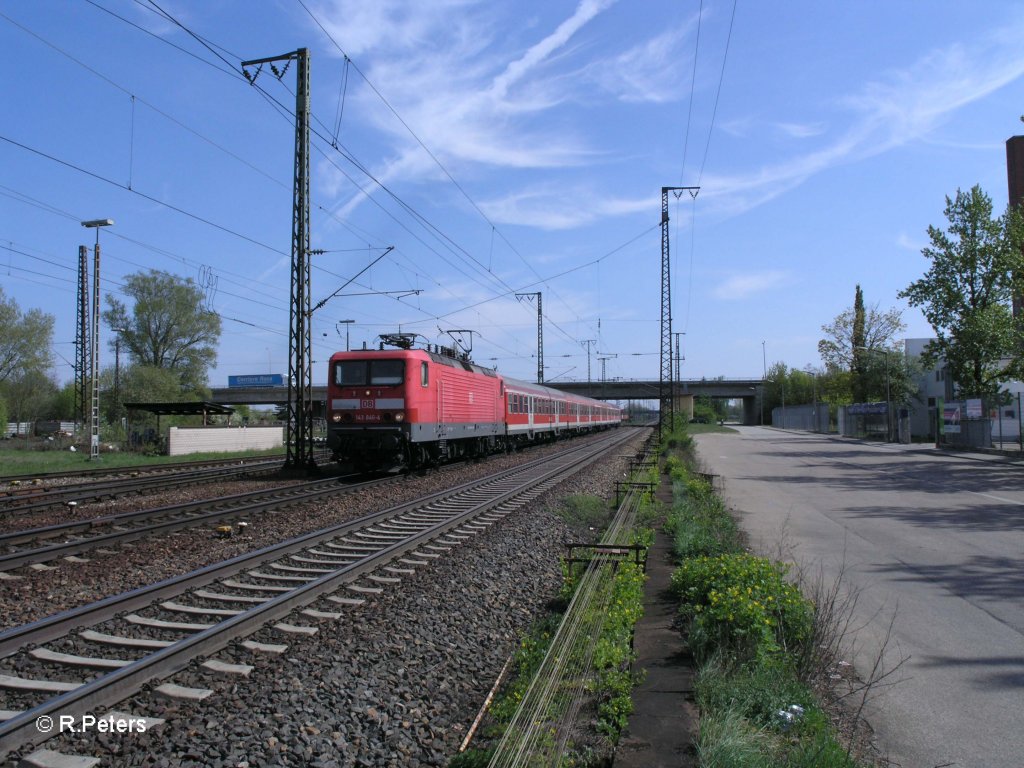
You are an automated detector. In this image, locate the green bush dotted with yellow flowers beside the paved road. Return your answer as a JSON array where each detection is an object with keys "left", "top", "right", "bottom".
[{"left": 672, "top": 554, "right": 812, "bottom": 658}]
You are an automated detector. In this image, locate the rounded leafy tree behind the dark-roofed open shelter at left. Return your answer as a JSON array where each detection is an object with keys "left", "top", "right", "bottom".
[{"left": 103, "top": 270, "right": 220, "bottom": 390}]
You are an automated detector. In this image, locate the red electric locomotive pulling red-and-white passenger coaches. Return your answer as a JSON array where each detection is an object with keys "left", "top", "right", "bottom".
[{"left": 326, "top": 342, "right": 623, "bottom": 472}]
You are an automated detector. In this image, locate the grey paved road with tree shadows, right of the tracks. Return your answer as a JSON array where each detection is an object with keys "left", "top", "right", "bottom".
[{"left": 697, "top": 427, "right": 1024, "bottom": 768}]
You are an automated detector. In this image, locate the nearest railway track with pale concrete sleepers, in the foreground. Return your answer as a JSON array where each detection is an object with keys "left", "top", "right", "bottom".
[{"left": 0, "top": 430, "right": 633, "bottom": 757}]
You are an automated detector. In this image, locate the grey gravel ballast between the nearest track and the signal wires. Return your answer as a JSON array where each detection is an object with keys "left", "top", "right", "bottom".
[{"left": 5, "top": 435, "right": 643, "bottom": 768}]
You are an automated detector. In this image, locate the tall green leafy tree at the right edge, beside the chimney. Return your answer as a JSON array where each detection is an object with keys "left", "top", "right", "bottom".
[{"left": 899, "top": 185, "right": 1024, "bottom": 397}]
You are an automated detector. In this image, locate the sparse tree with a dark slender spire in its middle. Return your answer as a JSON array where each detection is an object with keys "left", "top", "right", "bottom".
[{"left": 818, "top": 286, "right": 906, "bottom": 402}]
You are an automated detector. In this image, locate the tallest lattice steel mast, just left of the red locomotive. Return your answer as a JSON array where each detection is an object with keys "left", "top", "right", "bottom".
[{"left": 242, "top": 48, "right": 316, "bottom": 470}]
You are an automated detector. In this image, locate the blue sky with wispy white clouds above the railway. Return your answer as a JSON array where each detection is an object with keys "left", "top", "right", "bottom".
[{"left": 0, "top": 0, "right": 1024, "bottom": 385}]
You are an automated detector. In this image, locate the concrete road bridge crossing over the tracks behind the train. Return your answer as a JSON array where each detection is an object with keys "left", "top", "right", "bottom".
[{"left": 210, "top": 379, "right": 764, "bottom": 424}]
